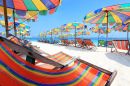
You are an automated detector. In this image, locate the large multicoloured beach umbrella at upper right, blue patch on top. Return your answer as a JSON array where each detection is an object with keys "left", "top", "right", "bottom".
[{"left": 84, "top": 3, "right": 130, "bottom": 51}]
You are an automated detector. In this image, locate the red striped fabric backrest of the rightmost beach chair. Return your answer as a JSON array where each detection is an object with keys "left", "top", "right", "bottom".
[{"left": 113, "top": 40, "right": 129, "bottom": 50}]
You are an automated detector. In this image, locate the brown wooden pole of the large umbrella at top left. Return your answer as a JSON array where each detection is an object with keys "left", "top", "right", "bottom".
[{"left": 3, "top": 0, "right": 9, "bottom": 38}]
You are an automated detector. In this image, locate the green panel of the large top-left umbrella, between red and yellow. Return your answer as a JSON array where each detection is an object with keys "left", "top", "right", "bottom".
[{"left": 23, "top": 0, "right": 38, "bottom": 11}]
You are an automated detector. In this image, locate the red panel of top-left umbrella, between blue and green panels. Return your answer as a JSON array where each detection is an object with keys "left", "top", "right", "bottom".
[{"left": 13, "top": 0, "right": 27, "bottom": 11}]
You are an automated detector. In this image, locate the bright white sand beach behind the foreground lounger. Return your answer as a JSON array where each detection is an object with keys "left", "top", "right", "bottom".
[{"left": 32, "top": 42, "right": 130, "bottom": 86}]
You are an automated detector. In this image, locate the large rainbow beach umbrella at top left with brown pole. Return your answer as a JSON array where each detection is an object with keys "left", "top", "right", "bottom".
[{"left": 0, "top": 0, "right": 61, "bottom": 37}]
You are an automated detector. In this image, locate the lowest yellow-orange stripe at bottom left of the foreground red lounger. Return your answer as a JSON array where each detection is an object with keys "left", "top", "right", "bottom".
[{"left": 0, "top": 65, "right": 35, "bottom": 86}]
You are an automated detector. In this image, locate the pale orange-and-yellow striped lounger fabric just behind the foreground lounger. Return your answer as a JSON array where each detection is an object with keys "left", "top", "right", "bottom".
[{"left": 47, "top": 52, "right": 72, "bottom": 64}]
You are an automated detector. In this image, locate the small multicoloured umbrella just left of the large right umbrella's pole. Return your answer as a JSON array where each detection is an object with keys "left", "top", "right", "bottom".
[{"left": 89, "top": 26, "right": 111, "bottom": 44}]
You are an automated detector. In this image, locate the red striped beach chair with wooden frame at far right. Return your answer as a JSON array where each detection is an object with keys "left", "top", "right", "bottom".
[{"left": 111, "top": 40, "right": 130, "bottom": 55}]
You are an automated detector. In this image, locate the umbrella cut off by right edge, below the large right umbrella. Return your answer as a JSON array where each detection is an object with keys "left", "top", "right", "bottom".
[{"left": 111, "top": 22, "right": 130, "bottom": 40}]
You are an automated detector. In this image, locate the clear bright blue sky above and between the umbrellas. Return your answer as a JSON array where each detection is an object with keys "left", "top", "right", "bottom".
[{"left": 0, "top": 0, "right": 130, "bottom": 37}]
